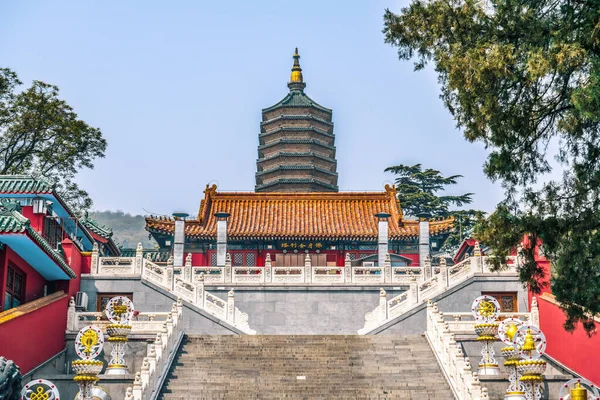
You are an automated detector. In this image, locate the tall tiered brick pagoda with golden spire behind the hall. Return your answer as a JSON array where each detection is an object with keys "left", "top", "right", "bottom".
[{"left": 255, "top": 48, "right": 338, "bottom": 193}]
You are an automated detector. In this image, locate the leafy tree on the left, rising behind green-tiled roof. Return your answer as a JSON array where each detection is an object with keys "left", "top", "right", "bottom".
[{"left": 0, "top": 68, "right": 106, "bottom": 213}]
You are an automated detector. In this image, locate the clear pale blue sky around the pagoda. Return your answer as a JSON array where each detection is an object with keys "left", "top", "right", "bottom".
[{"left": 0, "top": 0, "right": 502, "bottom": 214}]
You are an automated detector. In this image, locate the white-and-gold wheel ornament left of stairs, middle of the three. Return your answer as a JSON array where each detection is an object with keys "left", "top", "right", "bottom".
[{"left": 72, "top": 325, "right": 104, "bottom": 400}]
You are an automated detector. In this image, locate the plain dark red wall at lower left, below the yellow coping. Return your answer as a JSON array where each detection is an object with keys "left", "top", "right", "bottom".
[{"left": 0, "top": 296, "right": 69, "bottom": 374}]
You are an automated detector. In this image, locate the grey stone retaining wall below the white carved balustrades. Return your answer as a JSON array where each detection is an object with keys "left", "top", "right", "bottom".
[{"left": 81, "top": 274, "right": 528, "bottom": 335}]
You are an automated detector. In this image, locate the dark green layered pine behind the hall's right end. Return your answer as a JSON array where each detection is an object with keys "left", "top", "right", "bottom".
[{"left": 385, "top": 164, "right": 483, "bottom": 251}]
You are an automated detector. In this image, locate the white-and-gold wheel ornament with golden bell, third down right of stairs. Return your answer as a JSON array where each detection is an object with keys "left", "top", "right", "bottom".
[{"left": 513, "top": 325, "right": 546, "bottom": 400}]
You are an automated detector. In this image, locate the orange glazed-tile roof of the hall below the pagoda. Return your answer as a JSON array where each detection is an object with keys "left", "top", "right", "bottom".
[{"left": 146, "top": 185, "right": 454, "bottom": 242}]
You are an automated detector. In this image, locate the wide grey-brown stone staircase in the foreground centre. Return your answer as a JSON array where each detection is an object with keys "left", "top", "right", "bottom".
[{"left": 158, "top": 335, "right": 454, "bottom": 400}]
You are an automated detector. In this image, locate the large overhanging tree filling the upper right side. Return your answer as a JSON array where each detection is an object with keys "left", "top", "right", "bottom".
[{"left": 383, "top": 0, "right": 600, "bottom": 332}]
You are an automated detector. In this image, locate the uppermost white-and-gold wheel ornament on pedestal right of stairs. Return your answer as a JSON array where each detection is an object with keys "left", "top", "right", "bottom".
[{"left": 471, "top": 296, "right": 500, "bottom": 375}]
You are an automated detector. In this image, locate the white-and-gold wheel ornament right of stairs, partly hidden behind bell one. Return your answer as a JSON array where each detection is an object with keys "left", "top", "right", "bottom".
[{"left": 498, "top": 318, "right": 526, "bottom": 400}]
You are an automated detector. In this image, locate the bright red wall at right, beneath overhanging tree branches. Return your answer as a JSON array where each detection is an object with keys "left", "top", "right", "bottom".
[{"left": 538, "top": 297, "right": 600, "bottom": 384}]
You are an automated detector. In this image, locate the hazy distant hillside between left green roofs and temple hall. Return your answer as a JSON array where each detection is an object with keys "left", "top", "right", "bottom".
[{"left": 89, "top": 211, "right": 156, "bottom": 249}]
